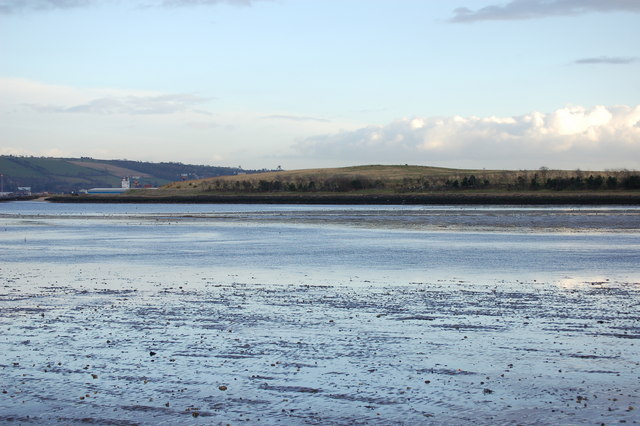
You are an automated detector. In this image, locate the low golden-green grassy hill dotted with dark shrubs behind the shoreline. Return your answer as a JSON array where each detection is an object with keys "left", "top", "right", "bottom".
[{"left": 163, "top": 165, "right": 640, "bottom": 194}]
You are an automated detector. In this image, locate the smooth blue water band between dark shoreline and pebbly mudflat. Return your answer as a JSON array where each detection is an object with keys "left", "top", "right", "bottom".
[{"left": 0, "top": 202, "right": 640, "bottom": 284}]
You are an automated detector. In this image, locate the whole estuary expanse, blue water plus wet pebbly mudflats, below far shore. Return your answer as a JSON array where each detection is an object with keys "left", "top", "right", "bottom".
[{"left": 0, "top": 202, "right": 640, "bottom": 424}]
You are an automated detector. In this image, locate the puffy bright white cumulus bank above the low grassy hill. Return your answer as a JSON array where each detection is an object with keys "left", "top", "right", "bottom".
[{"left": 295, "top": 105, "right": 640, "bottom": 169}]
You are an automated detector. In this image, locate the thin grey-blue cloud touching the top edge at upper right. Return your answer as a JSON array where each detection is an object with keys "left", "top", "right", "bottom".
[{"left": 451, "top": 0, "right": 640, "bottom": 23}]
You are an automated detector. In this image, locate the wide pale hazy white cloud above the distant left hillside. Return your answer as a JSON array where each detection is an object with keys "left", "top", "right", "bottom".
[{"left": 0, "top": 77, "right": 352, "bottom": 168}]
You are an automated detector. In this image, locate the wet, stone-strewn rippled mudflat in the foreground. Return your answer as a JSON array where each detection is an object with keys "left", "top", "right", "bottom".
[{"left": 0, "top": 263, "right": 640, "bottom": 425}]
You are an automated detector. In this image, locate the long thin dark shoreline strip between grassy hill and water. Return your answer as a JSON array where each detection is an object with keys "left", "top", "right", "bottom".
[{"left": 45, "top": 193, "right": 640, "bottom": 205}]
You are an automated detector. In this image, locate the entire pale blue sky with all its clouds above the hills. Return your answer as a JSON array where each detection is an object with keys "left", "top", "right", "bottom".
[{"left": 0, "top": 0, "right": 640, "bottom": 170}]
